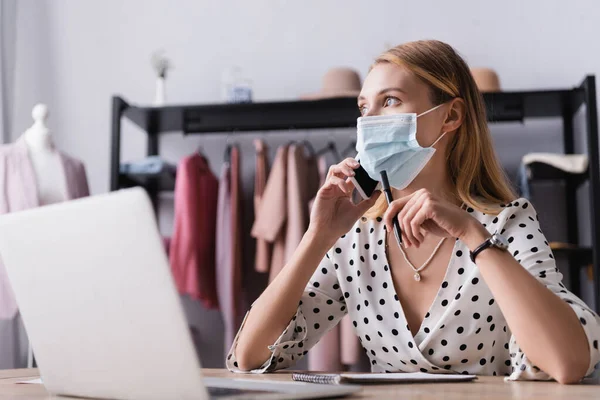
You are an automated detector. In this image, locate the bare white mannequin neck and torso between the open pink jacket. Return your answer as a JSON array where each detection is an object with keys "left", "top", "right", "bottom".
[{"left": 24, "top": 104, "right": 67, "bottom": 205}]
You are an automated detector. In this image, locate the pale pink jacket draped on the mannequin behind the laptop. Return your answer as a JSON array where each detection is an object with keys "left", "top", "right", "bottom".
[{"left": 0, "top": 138, "right": 90, "bottom": 319}]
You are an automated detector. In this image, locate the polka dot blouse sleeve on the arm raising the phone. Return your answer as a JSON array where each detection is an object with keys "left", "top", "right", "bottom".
[{"left": 226, "top": 250, "right": 347, "bottom": 373}]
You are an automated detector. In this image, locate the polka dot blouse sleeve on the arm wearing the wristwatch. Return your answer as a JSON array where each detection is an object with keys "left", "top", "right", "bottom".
[{"left": 499, "top": 199, "right": 600, "bottom": 380}]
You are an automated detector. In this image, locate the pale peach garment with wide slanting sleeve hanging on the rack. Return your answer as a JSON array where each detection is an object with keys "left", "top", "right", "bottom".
[{"left": 251, "top": 146, "right": 288, "bottom": 282}]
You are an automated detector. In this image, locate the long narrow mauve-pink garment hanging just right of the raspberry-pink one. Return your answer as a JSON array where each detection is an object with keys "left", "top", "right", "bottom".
[{"left": 216, "top": 146, "right": 242, "bottom": 354}]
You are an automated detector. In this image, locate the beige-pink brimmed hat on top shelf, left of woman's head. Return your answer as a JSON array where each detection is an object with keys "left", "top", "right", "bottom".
[{"left": 300, "top": 67, "right": 361, "bottom": 100}]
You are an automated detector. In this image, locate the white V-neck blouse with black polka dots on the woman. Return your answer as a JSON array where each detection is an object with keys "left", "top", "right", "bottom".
[{"left": 227, "top": 199, "right": 600, "bottom": 380}]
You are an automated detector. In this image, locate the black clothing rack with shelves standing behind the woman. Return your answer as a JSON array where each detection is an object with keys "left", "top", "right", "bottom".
[{"left": 110, "top": 75, "right": 600, "bottom": 311}]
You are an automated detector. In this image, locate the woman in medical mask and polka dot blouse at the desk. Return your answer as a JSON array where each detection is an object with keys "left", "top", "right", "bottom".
[{"left": 227, "top": 41, "right": 600, "bottom": 383}]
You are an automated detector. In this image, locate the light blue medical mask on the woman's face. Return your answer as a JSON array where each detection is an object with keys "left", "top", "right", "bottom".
[{"left": 356, "top": 104, "right": 446, "bottom": 190}]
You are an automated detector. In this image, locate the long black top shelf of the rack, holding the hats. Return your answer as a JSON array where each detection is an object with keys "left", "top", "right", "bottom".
[{"left": 119, "top": 89, "right": 581, "bottom": 134}]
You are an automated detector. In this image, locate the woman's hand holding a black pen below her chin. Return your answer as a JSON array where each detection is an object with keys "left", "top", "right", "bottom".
[{"left": 383, "top": 189, "right": 489, "bottom": 247}]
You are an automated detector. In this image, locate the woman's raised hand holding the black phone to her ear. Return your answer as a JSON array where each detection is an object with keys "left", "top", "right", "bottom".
[{"left": 309, "top": 158, "right": 381, "bottom": 240}]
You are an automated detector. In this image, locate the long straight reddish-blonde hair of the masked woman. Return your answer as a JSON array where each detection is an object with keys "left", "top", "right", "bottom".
[{"left": 365, "top": 40, "right": 516, "bottom": 218}]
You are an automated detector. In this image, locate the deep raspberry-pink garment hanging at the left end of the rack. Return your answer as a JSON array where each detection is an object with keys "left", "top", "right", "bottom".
[{"left": 169, "top": 154, "right": 219, "bottom": 308}]
